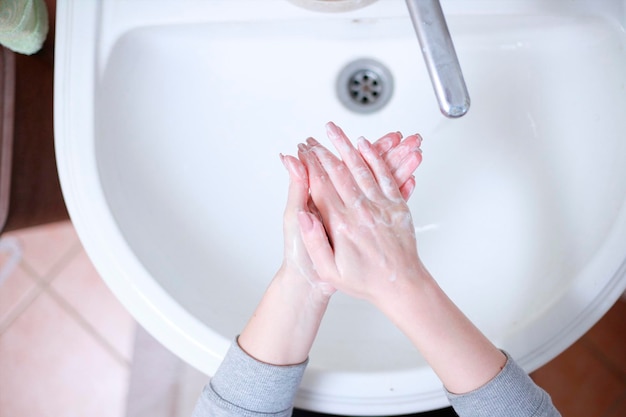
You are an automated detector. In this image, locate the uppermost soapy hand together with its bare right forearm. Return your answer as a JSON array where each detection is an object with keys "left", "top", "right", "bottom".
[{"left": 298, "top": 124, "right": 506, "bottom": 393}]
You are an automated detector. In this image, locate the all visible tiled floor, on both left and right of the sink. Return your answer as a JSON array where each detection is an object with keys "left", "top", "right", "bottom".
[{"left": 0, "top": 222, "right": 626, "bottom": 417}]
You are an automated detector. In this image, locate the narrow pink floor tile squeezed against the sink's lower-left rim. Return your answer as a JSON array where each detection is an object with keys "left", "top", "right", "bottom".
[{"left": 51, "top": 250, "right": 136, "bottom": 362}]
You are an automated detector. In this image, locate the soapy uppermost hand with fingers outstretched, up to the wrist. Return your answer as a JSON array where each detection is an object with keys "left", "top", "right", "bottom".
[{"left": 298, "top": 123, "right": 425, "bottom": 304}]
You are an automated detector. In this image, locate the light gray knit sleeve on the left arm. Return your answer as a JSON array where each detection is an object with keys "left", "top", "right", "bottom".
[{"left": 193, "top": 341, "right": 307, "bottom": 417}]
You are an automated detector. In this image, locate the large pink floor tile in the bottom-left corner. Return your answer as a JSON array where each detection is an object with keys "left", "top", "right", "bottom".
[{"left": 0, "top": 293, "right": 129, "bottom": 417}]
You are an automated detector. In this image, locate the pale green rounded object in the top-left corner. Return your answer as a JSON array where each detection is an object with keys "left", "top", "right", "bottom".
[{"left": 0, "top": 0, "right": 48, "bottom": 55}]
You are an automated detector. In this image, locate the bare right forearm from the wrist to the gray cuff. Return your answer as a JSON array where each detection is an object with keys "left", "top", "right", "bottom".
[{"left": 379, "top": 270, "right": 506, "bottom": 394}]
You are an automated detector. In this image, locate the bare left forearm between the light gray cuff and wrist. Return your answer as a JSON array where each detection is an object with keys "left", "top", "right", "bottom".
[{"left": 239, "top": 268, "right": 330, "bottom": 365}]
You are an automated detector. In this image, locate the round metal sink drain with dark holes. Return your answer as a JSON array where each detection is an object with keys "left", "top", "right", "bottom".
[{"left": 337, "top": 59, "right": 393, "bottom": 113}]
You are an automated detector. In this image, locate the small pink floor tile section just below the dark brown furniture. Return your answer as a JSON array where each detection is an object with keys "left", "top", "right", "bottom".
[{"left": 3, "top": 221, "right": 79, "bottom": 278}]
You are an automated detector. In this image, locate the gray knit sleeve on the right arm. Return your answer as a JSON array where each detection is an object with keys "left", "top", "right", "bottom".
[{"left": 447, "top": 352, "right": 561, "bottom": 417}]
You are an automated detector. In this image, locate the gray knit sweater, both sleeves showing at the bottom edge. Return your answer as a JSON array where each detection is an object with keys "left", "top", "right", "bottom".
[{"left": 193, "top": 342, "right": 560, "bottom": 417}]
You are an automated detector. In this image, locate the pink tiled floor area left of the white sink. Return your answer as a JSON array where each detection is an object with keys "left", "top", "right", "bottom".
[{"left": 0, "top": 222, "right": 135, "bottom": 417}]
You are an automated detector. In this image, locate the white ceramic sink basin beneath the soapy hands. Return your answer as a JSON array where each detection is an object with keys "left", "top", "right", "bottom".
[{"left": 55, "top": 0, "right": 626, "bottom": 415}]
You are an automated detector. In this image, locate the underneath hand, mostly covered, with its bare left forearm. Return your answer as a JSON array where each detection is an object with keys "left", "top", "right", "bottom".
[{"left": 238, "top": 123, "right": 421, "bottom": 365}]
